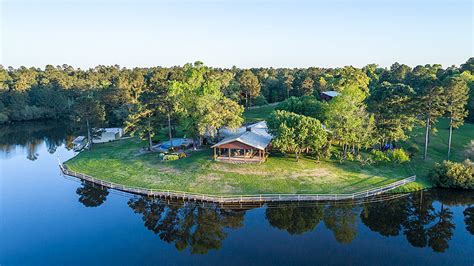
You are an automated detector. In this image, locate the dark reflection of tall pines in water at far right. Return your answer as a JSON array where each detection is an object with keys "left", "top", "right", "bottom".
[{"left": 361, "top": 190, "right": 474, "bottom": 252}]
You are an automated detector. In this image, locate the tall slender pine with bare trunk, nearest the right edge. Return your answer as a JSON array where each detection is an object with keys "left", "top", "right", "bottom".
[{"left": 444, "top": 77, "right": 468, "bottom": 160}]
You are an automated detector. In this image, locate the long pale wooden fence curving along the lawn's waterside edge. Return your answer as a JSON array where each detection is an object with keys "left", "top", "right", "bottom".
[{"left": 59, "top": 163, "right": 416, "bottom": 203}]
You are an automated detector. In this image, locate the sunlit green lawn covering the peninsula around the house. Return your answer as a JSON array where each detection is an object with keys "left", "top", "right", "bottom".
[{"left": 66, "top": 106, "right": 474, "bottom": 195}]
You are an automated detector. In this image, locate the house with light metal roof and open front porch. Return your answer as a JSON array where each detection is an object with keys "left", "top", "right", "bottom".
[{"left": 211, "top": 121, "right": 272, "bottom": 163}]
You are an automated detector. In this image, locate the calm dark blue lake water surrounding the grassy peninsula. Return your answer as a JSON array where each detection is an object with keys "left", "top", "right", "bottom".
[{"left": 0, "top": 123, "right": 474, "bottom": 265}]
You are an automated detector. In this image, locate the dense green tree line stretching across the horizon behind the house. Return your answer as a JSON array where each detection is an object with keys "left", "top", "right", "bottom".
[{"left": 0, "top": 58, "right": 474, "bottom": 156}]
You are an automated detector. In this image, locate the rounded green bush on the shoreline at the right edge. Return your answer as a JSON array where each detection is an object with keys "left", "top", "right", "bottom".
[{"left": 431, "top": 160, "right": 474, "bottom": 189}]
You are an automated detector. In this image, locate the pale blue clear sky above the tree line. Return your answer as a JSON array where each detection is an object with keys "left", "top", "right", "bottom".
[{"left": 0, "top": 0, "right": 474, "bottom": 68}]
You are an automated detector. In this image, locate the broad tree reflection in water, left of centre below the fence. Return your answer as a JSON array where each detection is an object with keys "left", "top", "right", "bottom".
[{"left": 128, "top": 197, "right": 245, "bottom": 254}]
